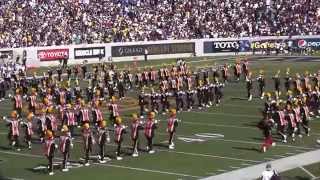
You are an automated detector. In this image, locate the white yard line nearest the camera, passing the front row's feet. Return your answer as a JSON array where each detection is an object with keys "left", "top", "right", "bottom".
[{"left": 0, "top": 150, "right": 202, "bottom": 178}]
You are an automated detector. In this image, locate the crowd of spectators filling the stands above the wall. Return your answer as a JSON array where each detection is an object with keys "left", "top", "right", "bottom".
[{"left": 0, "top": 0, "right": 320, "bottom": 48}]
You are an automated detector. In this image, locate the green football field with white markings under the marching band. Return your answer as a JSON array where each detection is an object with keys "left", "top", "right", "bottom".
[{"left": 0, "top": 56, "right": 320, "bottom": 180}]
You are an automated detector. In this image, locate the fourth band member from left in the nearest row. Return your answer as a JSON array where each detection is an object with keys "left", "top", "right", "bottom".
[{"left": 98, "top": 121, "right": 110, "bottom": 163}]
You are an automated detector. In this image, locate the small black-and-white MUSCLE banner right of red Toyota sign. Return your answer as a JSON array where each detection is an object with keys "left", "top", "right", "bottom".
[{"left": 74, "top": 47, "right": 106, "bottom": 59}]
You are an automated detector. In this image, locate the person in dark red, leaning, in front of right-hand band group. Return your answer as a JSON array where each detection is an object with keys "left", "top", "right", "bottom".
[{"left": 258, "top": 115, "right": 275, "bottom": 152}]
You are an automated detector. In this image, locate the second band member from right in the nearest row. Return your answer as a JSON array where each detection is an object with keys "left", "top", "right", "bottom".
[{"left": 144, "top": 112, "right": 157, "bottom": 154}]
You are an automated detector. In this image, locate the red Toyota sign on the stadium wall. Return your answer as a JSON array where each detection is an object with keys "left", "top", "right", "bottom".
[{"left": 38, "top": 49, "right": 69, "bottom": 61}]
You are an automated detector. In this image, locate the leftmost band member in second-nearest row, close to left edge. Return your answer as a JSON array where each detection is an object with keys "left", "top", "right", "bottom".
[{"left": 4, "top": 111, "right": 20, "bottom": 151}]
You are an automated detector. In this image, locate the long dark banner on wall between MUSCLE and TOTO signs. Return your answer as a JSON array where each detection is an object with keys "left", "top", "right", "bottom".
[{"left": 111, "top": 42, "right": 195, "bottom": 57}]
